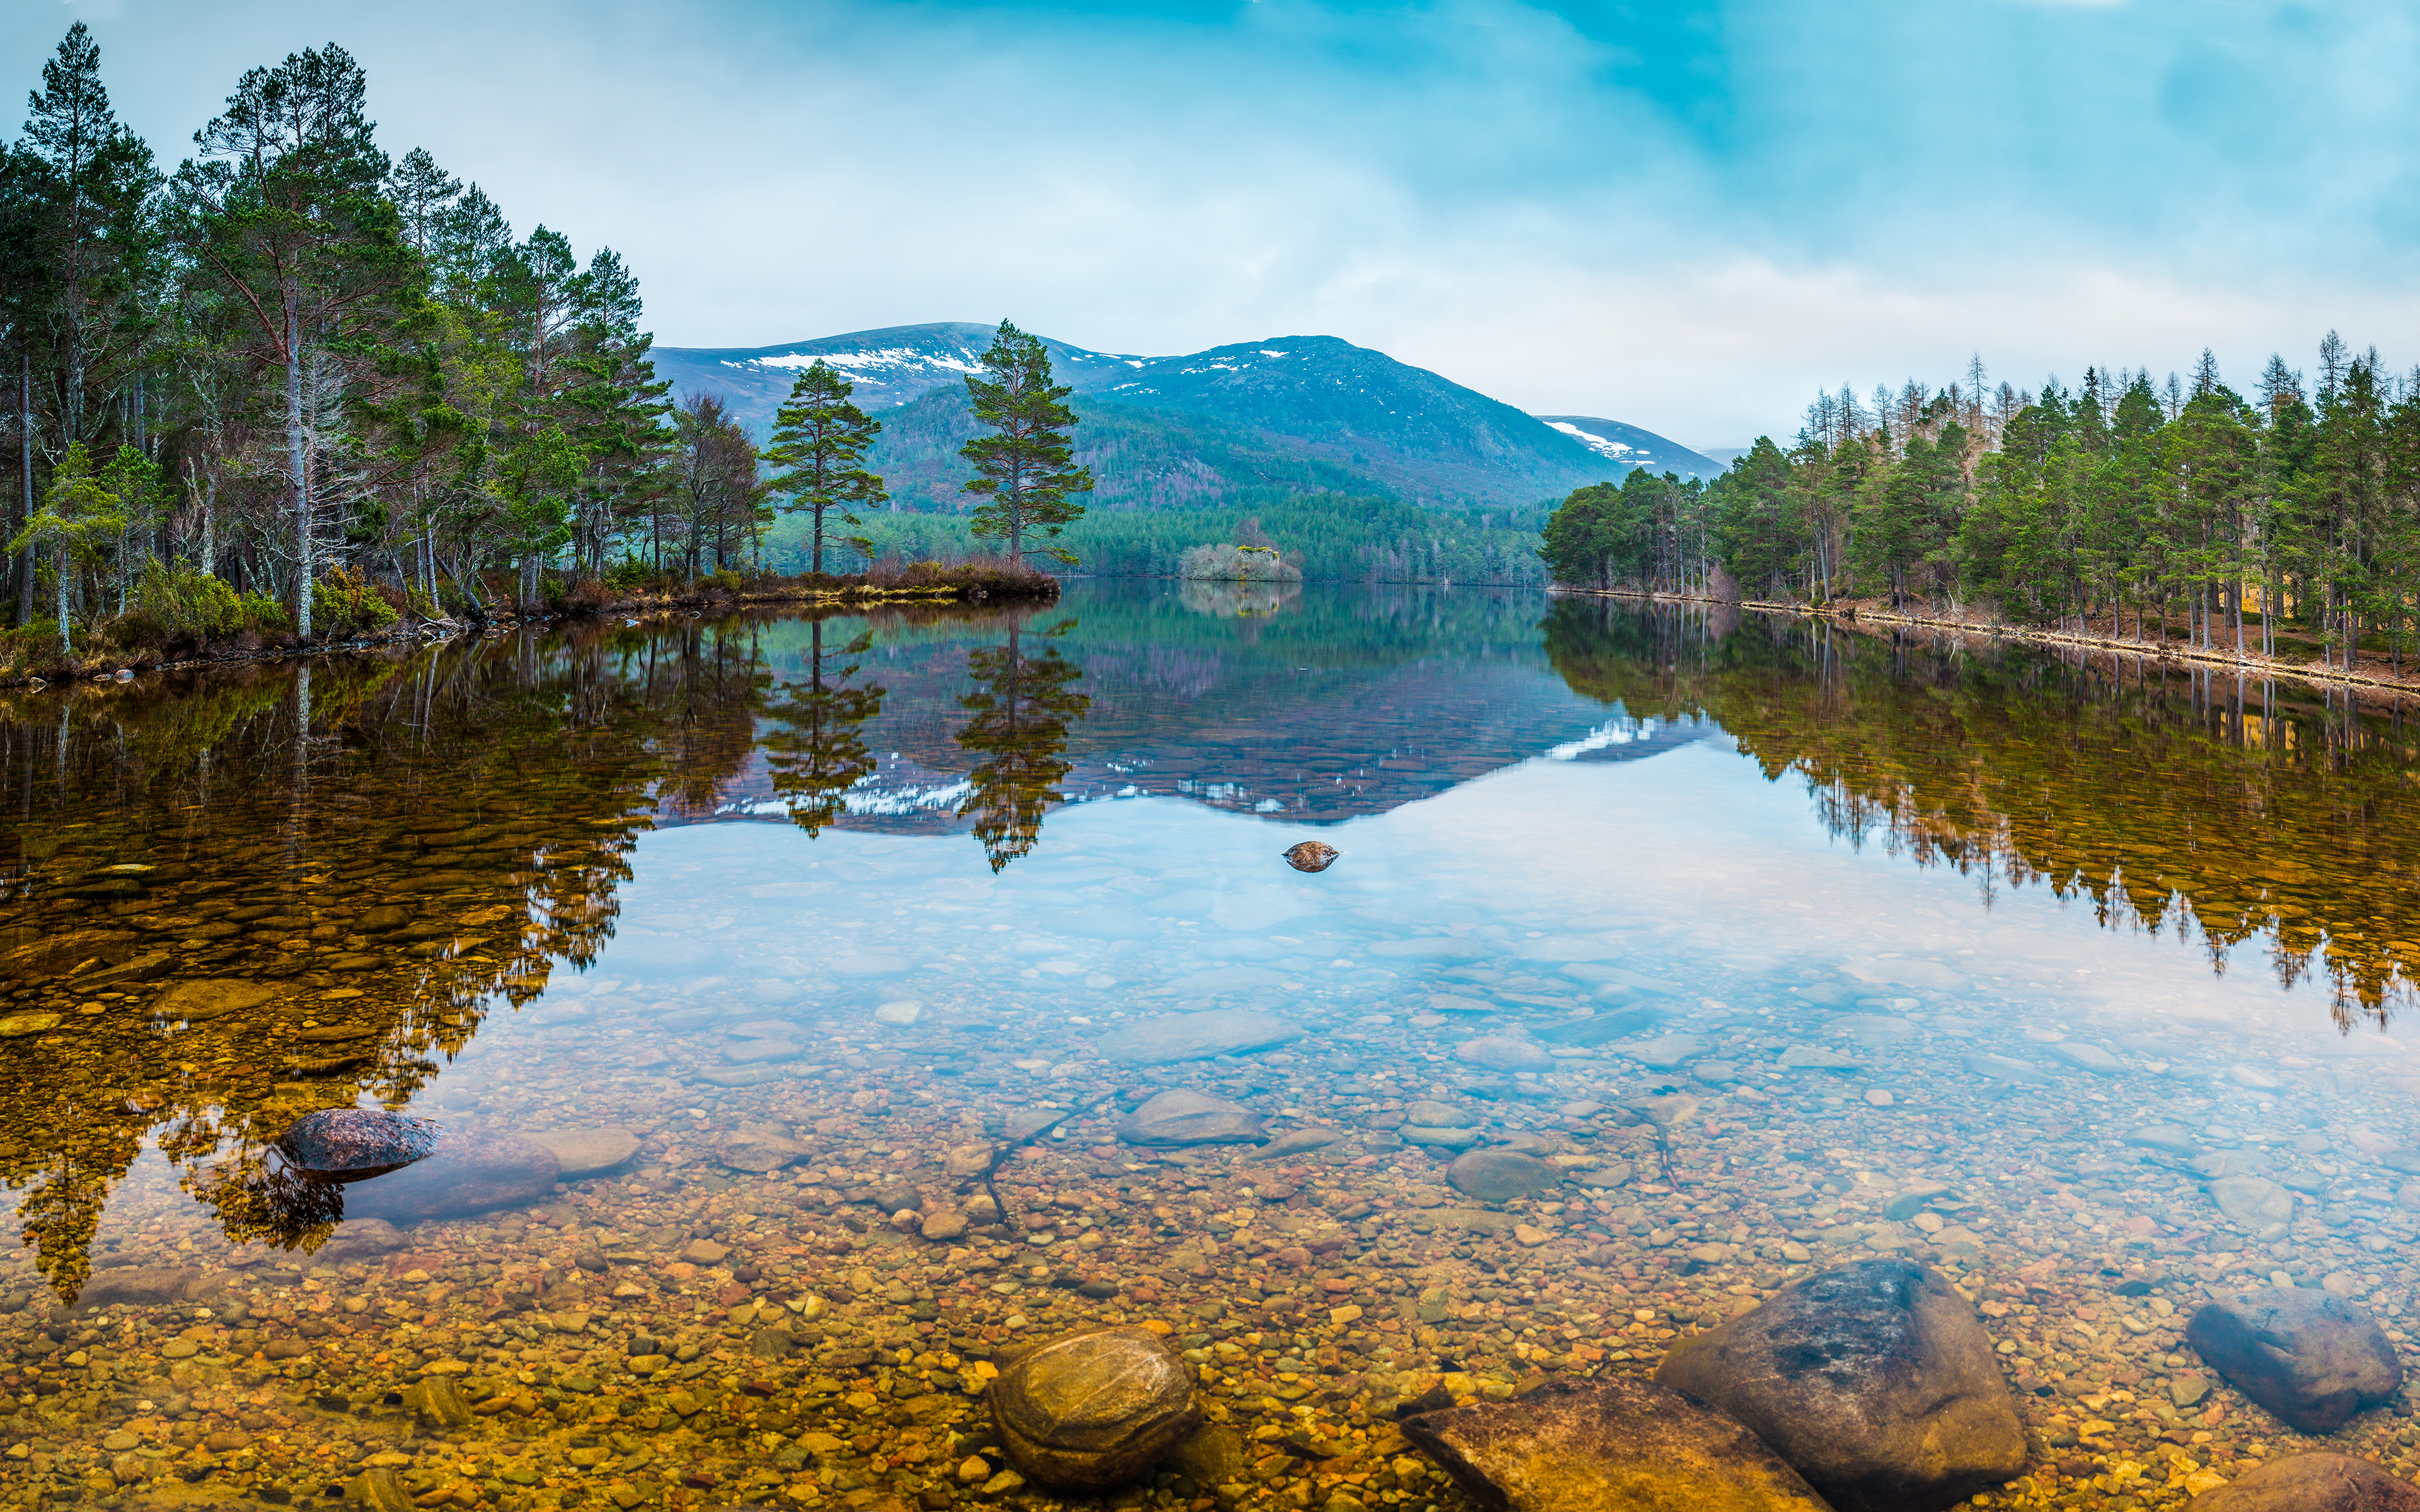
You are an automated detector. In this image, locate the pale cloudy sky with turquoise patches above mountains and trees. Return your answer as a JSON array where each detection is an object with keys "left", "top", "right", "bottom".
[{"left": 0, "top": 0, "right": 2420, "bottom": 447}]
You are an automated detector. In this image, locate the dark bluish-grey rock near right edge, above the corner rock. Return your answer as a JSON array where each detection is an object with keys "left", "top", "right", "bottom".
[{"left": 2186, "top": 1287, "right": 2403, "bottom": 1432}]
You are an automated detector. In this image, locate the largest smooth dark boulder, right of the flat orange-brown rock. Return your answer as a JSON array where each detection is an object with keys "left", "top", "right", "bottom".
[{"left": 1656, "top": 1261, "right": 2025, "bottom": 1512}]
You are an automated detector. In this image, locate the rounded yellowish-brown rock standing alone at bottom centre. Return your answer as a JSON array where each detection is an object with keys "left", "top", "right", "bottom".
[{"left": 992, "top": 1328, "right": 1201, "bottom": 1490}]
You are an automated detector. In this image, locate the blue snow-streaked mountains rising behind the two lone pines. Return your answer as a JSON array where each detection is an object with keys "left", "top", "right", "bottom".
[{"left": 654, "top": 322, "right": 1645, "bottom": 508}]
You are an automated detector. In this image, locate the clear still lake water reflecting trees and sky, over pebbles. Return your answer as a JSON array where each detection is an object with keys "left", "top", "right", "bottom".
[{"left": 0, "top": 585, "right": 2420, "bottom": 1509}]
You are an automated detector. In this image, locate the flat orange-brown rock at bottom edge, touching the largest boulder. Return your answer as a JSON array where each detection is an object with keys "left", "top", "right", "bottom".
[{"left": 1401, "top": 1377, "right": 1829, "bottom": 1512}]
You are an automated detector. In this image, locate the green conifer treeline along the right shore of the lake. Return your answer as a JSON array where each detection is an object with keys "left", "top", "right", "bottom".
[{"left": 1541, "top": 331, "right": 2420, "bottom": 665}]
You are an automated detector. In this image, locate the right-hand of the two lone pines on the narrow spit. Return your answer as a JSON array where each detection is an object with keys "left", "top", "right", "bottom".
[{"left": 959, "top": 322, "right": 1092, "bottom": 566}]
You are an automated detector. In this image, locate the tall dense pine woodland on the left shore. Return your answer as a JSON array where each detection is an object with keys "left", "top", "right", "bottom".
[{"left": 0, "top": 22, "right": 764, "bottom": 643}]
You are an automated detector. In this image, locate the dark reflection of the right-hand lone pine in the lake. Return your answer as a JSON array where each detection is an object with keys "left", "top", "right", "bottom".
[{"left": 959, "top": 619, "right": 1092, "bottom": 871}]
